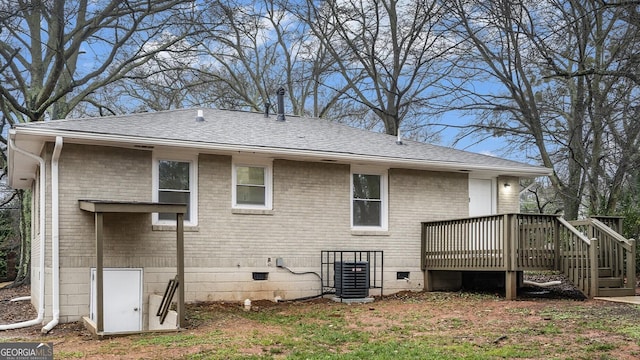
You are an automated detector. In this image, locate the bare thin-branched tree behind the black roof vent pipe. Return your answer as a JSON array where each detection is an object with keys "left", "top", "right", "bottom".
[{"left": 192, "top": 0, "right": 356, "bottom": 117}]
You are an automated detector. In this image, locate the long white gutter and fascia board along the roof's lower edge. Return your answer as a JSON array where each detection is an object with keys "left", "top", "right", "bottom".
[{"left": 8, "top": 128, "right": 552, "bottom": 177}]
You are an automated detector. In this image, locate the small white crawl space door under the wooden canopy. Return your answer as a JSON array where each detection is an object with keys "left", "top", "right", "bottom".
[{"left": 89, "top": 268, "right": 142, "bottom": 333}]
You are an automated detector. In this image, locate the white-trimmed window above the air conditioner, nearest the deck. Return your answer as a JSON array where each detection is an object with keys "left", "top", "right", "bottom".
[{"left": 351, "top": 169, "right": 388, "bottom": 230}]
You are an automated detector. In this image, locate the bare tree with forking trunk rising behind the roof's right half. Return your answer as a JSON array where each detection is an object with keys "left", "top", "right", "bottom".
[{"left": 296, "top": 0, "right": 453, "bottom": 135}]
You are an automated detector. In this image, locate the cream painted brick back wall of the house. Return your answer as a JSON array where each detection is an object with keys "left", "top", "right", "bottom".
[{"left": 40, "top": 144, "right": 510, "bottom": 321}]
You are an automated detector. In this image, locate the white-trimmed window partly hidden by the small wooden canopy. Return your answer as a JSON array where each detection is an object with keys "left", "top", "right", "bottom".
[{"left": 153, "top": 157, "right": 198, "bottom": 225}]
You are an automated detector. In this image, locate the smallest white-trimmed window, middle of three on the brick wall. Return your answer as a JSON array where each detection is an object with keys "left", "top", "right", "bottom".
[{"left": 232, "top": 162, "right": 273, "bottom": 210}]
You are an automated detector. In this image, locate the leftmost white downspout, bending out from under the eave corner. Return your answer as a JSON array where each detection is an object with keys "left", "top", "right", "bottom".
[{"left": 0, "top": 136, "right": 47, "bottom": 330}]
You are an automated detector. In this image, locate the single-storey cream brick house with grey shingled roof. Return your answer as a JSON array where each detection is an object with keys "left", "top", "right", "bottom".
[{"left": 8, "top": 109, "right": 549, "bottom": 332}]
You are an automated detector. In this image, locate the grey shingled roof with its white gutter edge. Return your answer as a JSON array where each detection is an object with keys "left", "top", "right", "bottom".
[{"left": 12, "top": 109, "right": 549, "bottom": 187}]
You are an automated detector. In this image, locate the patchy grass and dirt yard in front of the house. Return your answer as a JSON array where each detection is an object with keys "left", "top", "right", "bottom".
[{"left": 0, "top": 292, "right": 640, "bottom": 360}]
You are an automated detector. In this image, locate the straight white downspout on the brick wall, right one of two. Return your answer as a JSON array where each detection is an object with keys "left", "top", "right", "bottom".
[{"left": 42, "top": 136, "right": 62, "bottom": 334}]
